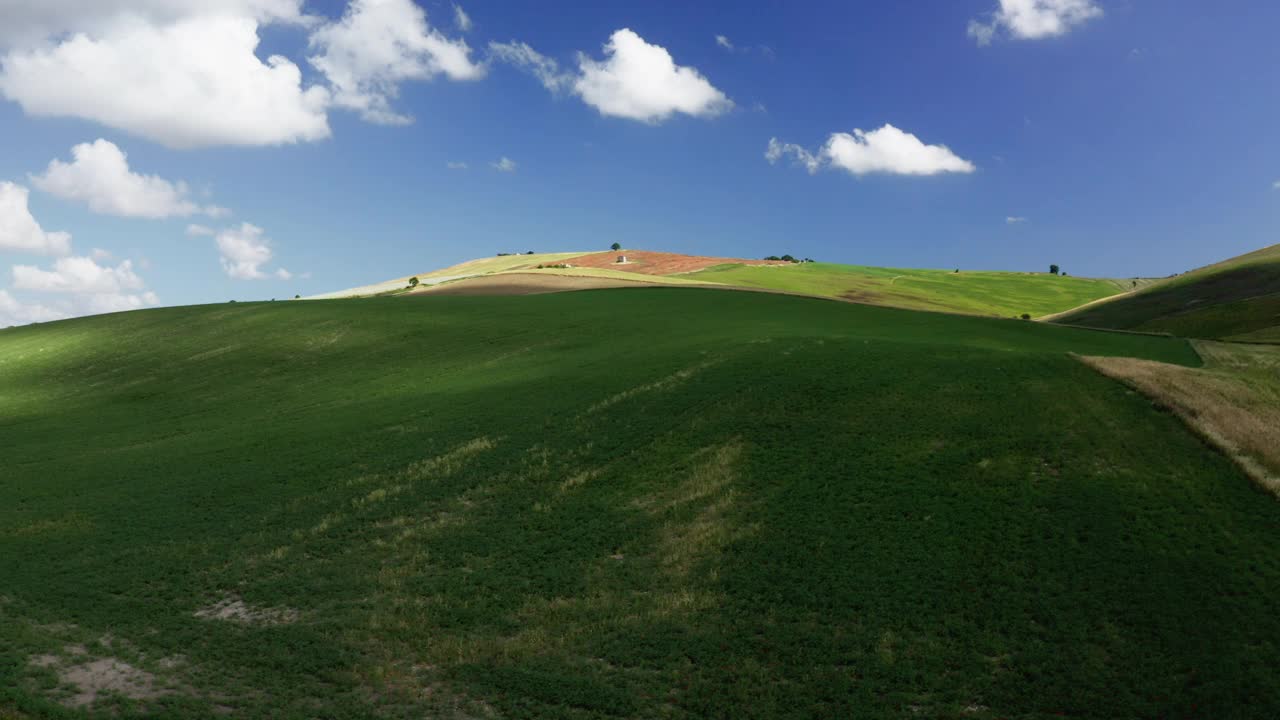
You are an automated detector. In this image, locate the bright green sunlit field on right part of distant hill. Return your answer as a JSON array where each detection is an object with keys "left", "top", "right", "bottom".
[{"left": 684, "top": 263, "right": 1120, "bottom": 318}]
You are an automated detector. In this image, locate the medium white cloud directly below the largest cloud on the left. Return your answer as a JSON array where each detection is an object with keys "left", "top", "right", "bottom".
[{"left": 31, "top": 140, "right": 225, "bottom": 219}]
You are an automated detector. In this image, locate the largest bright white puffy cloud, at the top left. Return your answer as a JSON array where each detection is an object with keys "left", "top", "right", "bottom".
[{"left": 0, "top": 13, "right": 329, "bottom": 147}]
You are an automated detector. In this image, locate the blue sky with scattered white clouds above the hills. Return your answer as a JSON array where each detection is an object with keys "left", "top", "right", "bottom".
[{"left": 0, "top": 0, "right": 1280, "bottom": 319}]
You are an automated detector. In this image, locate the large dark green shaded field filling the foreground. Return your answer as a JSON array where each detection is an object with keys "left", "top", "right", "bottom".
[{"left": 0, "top": 290, "right": 1280, "bottom": 719}]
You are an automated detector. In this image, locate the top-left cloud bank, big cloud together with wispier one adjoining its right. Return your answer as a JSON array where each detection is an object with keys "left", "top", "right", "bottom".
[{"left": 0, "top": 0, "right": 484, "bottom": 149}]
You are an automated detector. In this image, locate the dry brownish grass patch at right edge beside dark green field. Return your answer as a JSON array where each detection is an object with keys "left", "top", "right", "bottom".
[{"left": 1082, "top": 341, "right": 1280, "bottom": 496}]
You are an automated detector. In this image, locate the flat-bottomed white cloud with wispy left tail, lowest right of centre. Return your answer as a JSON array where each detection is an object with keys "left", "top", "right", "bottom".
[{"left": 764, "top": 123, "right": 977, "bottom": 176}]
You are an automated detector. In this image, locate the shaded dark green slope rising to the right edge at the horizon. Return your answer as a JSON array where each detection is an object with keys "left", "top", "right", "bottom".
[{"left": 1055, "top": 245, "right": 1280, "bottom": 342}]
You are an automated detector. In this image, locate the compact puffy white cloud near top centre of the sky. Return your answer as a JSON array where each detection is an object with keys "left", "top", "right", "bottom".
[{"left": 573, "top": 28, "right": 733, "bottom": 123}]
